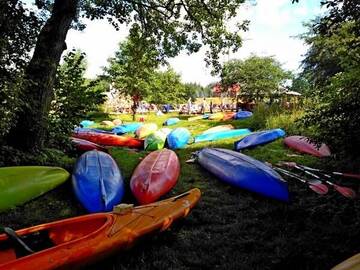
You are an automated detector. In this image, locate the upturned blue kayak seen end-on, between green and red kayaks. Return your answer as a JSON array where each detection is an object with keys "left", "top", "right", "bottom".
[{"left": 72, "top": 150, "right": 125, "bottom": 213}]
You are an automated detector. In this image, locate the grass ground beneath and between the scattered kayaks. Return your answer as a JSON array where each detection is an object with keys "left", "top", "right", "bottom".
[{"left": 0, "top": 110, "right": 360, "bottom": 270}]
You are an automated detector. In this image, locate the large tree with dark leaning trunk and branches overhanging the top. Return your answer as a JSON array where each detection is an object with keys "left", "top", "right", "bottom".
[{"left": 8, "top": 0, "right": 248, "bottom": 150}]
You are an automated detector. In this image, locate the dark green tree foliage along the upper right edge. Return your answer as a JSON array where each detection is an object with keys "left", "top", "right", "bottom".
[{"left": 303, "top": 0, "right": 360, "bottom": 158}]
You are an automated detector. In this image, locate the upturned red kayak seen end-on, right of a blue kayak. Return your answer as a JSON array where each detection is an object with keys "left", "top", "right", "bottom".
[{"left": 130, "top": 149, "right": 180, "bottom": 204}]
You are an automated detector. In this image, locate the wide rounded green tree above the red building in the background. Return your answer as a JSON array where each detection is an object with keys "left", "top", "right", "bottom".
[{"left": 221, "top": 55, "right": 290, "bottom": 100}]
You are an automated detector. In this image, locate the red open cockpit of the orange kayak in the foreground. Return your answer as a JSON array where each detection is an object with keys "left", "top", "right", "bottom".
[{"left": 0, "top": 215, "right": 111, "bottom": 265}]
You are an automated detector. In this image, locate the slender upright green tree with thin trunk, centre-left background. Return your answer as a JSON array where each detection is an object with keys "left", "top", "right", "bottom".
[{"left": 105, "top": 28, "right": 160, "bottom": 120}]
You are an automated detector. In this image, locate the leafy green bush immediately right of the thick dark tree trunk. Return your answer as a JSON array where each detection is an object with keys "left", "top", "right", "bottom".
[{"left": 48, "top": 51, "right": 108, "bottom": 149}]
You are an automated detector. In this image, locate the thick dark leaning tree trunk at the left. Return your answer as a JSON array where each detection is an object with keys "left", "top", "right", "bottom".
[{"left": 7, "top": 0, "right": 79, "bottom": 151}]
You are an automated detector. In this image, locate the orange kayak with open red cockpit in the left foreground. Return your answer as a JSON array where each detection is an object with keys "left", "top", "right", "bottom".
[{"left": 0, "top": 189, "right": 201, "bottom": 270}]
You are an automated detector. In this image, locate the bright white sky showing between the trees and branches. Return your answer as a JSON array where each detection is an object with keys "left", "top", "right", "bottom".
[{"left": 66, "top": 0, "right": 323, "bottom": 86}]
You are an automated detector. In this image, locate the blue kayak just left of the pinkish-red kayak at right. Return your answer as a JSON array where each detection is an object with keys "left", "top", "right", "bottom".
[{"left": 234, "top": 128, "right": 285, "bottom": 151}]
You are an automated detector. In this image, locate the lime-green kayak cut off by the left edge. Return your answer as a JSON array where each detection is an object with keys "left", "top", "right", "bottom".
[{"left": 0, "top": 166, "right": 70, "bottom": 212}]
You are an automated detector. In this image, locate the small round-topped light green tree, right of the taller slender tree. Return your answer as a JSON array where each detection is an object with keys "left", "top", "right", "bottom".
[{"left": 146, "top": 69, "right": 188, "bottom": 104}]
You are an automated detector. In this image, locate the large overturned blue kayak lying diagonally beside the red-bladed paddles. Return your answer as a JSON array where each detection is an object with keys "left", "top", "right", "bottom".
[{"left": 196, "top": 148, "right": 289, "bottom": 202}]
